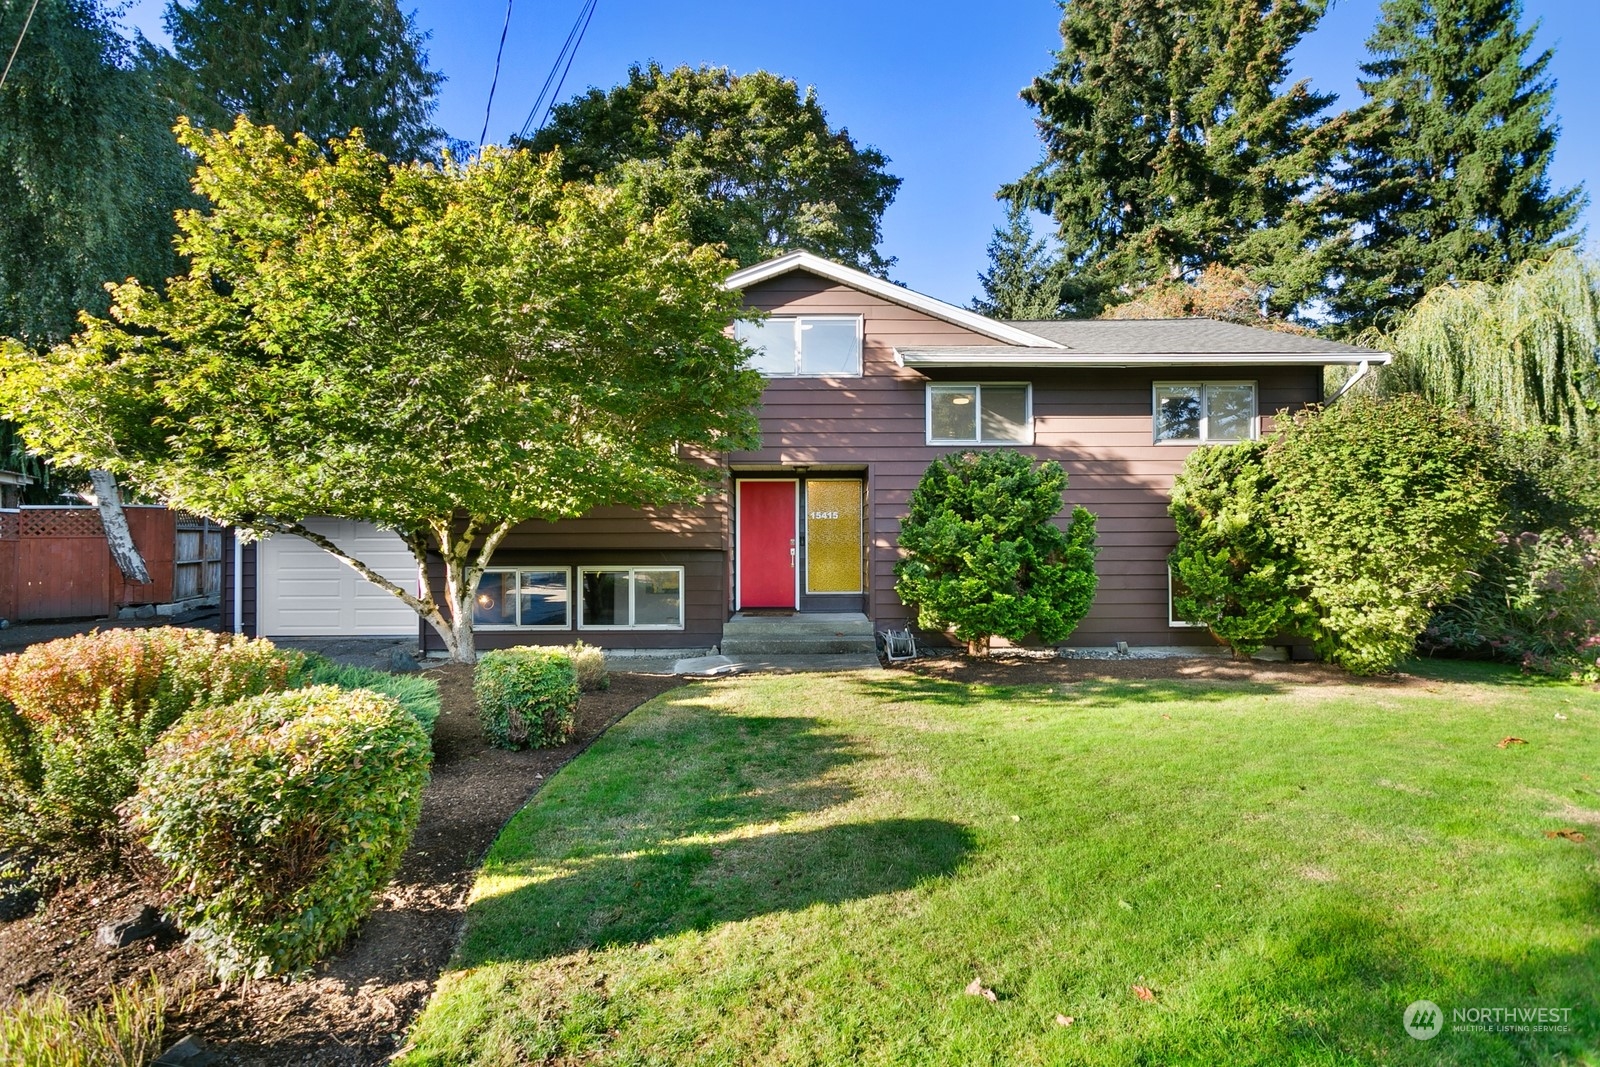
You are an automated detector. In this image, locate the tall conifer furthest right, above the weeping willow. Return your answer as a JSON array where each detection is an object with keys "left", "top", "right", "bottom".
[{"left": 1330, "top": 0, "right": 1586, "bottom": 333}]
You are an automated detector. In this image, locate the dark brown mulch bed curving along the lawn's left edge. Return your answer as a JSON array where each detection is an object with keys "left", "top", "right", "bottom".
[{"left": 0, "top": 665, "right": 680, "bottom": 1067}]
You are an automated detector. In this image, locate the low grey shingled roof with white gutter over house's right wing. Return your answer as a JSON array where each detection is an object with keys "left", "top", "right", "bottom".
[{"left": 894, "top": 318, "right": 1394, "bottom": 368}]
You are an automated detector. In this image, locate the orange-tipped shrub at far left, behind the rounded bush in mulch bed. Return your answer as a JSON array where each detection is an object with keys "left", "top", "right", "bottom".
[{"left": 0, "top": 627, "right": 299, "bottom": 881}]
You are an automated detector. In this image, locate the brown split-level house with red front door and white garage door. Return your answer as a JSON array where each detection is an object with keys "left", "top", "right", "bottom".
[{"left": 224, "top": 251, "right": 1389, "bottom": 648}]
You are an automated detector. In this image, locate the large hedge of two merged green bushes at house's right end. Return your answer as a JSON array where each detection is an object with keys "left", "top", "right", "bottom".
[{"left": 1171, "top": 397, "right": 1506, "bottom": 673}]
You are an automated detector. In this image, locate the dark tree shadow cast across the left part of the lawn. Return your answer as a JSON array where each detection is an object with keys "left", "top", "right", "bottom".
[{"left": 462, "top": 700, "right": 974, "bottom": 965}]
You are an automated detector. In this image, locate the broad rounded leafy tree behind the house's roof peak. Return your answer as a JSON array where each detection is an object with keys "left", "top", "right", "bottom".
[{"left": 526, "top": 62, "right": 901, "bottom": 275}]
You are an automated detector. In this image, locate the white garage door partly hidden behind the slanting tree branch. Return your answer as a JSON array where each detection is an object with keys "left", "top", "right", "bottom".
[{"left": 256, "top": 518, "right": 418, "bottom": 637}]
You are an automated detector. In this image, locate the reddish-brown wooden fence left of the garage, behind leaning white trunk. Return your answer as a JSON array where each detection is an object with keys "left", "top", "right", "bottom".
[{"left": 0, "top": 506, "right": 222, "bottom": 622}]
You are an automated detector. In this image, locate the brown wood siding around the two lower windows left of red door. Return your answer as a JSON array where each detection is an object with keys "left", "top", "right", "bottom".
[{"left": 422, "top": 549, "right": 728, "bottom": 651}]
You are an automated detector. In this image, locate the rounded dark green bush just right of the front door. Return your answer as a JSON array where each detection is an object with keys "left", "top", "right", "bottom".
[{"left": 894, "top": 450, "right": 1096, "bottom": 656}]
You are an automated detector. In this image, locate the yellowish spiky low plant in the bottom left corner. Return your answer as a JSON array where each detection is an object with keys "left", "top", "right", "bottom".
[{"left": 0, "top": 977, "right": 166, "bottom": 1067}]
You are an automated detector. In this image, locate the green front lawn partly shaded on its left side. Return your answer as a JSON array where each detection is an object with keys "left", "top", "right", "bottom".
[{"left": 398, "top": 665, "right": 1600, "bottom": 1067}]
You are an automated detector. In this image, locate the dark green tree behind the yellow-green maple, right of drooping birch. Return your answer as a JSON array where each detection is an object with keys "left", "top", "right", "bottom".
[{"left": 165, "top": 0, "right": 445, "bottom": 160}]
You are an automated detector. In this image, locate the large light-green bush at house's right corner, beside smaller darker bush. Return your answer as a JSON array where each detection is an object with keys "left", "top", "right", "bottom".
[{"left": 1267, "top": 395, "right": 1506, "bottom": 673}]
